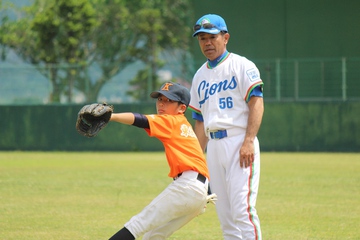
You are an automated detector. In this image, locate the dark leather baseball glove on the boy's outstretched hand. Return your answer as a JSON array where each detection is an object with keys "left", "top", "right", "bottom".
[{"left": 76, "top": 103, "right": 114, "bottom": 137}]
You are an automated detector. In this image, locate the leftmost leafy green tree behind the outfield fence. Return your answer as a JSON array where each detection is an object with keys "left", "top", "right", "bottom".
[{"left": 1, "top": 0, "right": 97, "bottom": 102}]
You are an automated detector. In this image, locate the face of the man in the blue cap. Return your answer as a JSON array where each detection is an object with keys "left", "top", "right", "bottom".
[{"left": 197, "top": 33, "right": 230, "bottom": 60}]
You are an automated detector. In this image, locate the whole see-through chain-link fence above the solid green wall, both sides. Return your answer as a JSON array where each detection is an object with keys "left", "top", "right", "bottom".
[{"left": 0, "top": 58, "right": 360, "bottom": 105}]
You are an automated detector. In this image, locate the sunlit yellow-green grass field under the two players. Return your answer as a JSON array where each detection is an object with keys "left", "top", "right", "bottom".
[{"left": 0, "top": 152, "right": 360, "bottom": 240}]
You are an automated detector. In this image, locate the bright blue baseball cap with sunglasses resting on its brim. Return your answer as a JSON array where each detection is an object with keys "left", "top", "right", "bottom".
[{"left": 193, "top": 14, "right": 228, "bottom": 37}]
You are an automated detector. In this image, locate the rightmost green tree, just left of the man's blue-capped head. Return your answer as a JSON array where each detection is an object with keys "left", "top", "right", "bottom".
[{"left": 127, "top": 0, "right": 193, "bottom": 101}]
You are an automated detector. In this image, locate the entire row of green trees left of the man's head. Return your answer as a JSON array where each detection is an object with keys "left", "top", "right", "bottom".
[{"left": 0, "top": 0, "right": 193, "bottom": 103}]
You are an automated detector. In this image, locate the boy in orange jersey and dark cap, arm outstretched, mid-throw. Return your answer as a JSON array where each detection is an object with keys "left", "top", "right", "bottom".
[{"left": 110, "top": 82, "right": 212, "bottom": 240}]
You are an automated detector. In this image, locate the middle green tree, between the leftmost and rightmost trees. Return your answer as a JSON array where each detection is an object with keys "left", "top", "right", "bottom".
[{"left": 77, "top": 0, "right": 138, "bottom": 101}]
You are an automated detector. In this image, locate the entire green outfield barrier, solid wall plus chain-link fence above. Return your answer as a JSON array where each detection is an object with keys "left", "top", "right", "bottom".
[{"left": 0, "top": 58, "right": 360, "bottom": 152}]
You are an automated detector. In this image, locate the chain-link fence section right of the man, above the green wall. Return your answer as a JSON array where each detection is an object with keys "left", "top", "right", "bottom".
[{"left": 255, "top": 57, "right": 360, "bottom": 101}]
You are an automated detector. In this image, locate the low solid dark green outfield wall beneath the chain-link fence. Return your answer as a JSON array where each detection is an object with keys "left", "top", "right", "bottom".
[{"left": 0, "top": 102, "right": 360, "bottom": 152}]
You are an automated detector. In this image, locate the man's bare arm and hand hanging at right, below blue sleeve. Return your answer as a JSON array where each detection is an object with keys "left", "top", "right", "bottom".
[{"left": 240, "top": 96, "right": 264, "bottom": 168}]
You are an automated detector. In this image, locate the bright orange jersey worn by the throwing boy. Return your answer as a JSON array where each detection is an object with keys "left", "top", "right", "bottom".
[{"left": 145, "top": 114, "right": 209, "bottom": 179}]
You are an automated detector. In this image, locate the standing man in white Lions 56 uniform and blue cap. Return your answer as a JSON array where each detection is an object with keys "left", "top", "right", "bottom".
[{"left": 189, "top": 14, "right": 264, "bottom": 240}]
